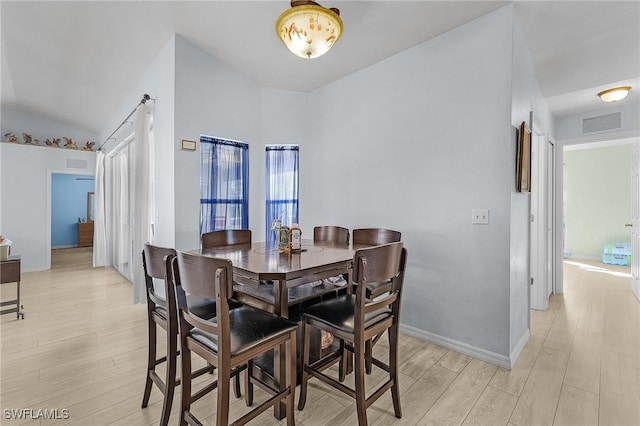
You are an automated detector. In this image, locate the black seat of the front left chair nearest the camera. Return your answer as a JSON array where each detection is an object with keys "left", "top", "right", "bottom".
[{"left": 191, "top": 306, "right": 298, "bottom": 355}]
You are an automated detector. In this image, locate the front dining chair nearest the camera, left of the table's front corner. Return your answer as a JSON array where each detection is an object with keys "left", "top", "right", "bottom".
[{"left": 171, "top": 251, "right": 298, "bottom": 426}]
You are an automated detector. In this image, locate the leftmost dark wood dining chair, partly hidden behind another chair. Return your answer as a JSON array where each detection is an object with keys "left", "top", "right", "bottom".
[{"left": 142, "top": 244, "right": 220, "bottom": 426}]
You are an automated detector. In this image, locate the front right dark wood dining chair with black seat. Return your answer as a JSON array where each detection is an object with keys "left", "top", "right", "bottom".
[{"left": 298, "top": 243, "right": 407, "bottom": 426}]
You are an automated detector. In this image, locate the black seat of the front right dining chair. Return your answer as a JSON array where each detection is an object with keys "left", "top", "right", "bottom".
[{"left": 303, "top": 294, "right": 391, "bottom": 333}]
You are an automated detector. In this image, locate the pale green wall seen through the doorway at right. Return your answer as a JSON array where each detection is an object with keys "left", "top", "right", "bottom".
[{"left": 564, "top": 145, "right": 631, "bottom": 259}]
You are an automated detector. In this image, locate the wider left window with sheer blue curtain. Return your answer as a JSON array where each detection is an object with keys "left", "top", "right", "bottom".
[{"left": 200, "top": 136, "right": 249, "bottom": 235}]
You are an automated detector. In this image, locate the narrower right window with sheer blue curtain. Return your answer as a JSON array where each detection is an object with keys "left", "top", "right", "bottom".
[{"left": 266, "top": 145, "right": 299, "bottom": 246}]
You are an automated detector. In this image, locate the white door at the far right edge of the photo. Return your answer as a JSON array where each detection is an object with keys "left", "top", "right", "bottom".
[{"left": 631, "top": 141, "right": 640, "bottom": 300}]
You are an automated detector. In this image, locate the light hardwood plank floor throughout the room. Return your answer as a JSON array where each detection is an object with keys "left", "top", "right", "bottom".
[{"left": 0, "top": 255, "right": 640, "bottom": 426}]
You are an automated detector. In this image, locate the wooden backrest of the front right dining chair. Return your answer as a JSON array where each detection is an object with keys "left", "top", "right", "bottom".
[{"left": 353, "top": 242, "right": 407, "bottom": 328}]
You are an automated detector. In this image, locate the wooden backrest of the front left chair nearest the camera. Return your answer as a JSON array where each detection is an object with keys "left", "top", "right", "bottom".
[{"left": 171, "top": 251, "right": 233, "bottom": 353}]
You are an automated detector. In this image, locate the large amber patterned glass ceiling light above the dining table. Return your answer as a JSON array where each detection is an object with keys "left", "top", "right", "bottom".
[{"left": 276, "top": 0, "right": 342, "bottom": 59}]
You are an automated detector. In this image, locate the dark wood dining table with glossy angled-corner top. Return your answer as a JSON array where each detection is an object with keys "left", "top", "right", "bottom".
[{"left": 194, "top": 239, "right": 355, "bottom": 419}]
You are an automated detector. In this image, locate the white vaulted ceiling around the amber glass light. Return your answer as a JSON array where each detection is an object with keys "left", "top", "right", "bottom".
[{"left": 0, "top": 0, "right": 640, "bottom": 132}]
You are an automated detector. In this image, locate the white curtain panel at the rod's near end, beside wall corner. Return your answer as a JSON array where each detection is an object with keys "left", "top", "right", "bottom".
[{"left": 131, "top": 104, "right": 155, "bottom": 303}]
